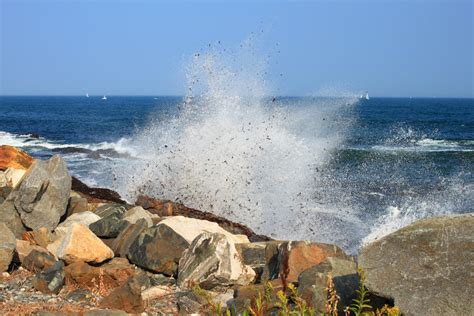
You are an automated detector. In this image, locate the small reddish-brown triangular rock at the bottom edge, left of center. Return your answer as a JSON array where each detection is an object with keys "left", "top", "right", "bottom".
[{"left": 101, "top": 277, "right": 145, "bottom": 313}]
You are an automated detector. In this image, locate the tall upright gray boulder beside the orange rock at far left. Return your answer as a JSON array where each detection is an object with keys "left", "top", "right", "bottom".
[{"left": 7, "top": 156, "right": 71, "bottom": 230}]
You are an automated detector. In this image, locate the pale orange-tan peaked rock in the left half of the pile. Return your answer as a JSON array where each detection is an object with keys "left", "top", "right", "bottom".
[{"left": 47, "top": 223, "right": 114, "bottom": 264}]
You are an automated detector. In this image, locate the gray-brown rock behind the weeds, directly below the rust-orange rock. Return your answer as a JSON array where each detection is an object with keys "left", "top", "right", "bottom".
[{"left": 298, "top": 257, "right": 359, "bottom": 314}]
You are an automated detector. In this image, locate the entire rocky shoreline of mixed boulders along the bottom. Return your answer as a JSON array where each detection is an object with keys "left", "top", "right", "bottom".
[{"left": 0, "top": 146, "right": 474, "bottom": 315}]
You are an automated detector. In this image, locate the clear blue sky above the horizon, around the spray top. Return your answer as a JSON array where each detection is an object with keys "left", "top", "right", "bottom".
[{"left": 0, "top": 0, "right": 474, "bottom": 97}]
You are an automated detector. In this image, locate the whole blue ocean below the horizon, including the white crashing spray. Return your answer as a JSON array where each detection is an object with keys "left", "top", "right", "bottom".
[{"left": 0, "top": 92, "right": 474, "bottom": 253}]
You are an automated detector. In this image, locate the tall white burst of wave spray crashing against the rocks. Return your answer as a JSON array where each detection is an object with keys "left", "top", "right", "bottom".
[{"left": 111, "top": 42, "right": 357, "bottom": 251}]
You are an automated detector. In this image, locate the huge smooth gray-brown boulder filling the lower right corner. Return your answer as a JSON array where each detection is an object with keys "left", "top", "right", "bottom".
[{"left": 359, "top": 213, "right": 474, "bottom": 315}]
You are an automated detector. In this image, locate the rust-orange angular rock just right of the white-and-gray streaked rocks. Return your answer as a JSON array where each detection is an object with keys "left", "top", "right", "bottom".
[{"left": 278, "top": 241, "right": 350, "bottom": 282}]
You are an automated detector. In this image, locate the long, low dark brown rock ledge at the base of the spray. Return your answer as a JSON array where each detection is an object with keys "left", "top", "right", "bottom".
[{"left": 135, "top": 195, "right": 271, "bottom": 242}]
